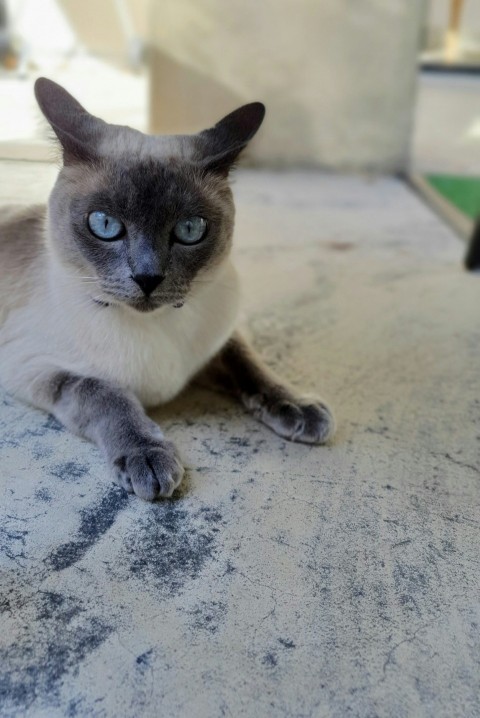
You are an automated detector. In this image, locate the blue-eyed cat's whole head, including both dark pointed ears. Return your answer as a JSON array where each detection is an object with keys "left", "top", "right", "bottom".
[{"left": 35, "top": 78, "right": 265, "bottom": 311}]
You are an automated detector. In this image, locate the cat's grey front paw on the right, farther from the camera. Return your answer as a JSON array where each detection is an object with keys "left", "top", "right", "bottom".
[{"left": 245, "top": 392, "right": 335, "bottom": 444}]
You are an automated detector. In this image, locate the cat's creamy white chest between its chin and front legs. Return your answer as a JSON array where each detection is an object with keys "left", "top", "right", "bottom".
[{"left": 73, "top": 267, "right": 239, "bottom": 407}]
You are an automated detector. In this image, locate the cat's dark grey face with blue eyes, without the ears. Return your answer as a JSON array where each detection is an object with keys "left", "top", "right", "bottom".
[{"left": 49, "top": 156, "right": 234, "bottom": 311}]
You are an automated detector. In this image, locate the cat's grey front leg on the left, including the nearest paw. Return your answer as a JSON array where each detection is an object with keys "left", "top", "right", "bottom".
[{"left": 30, "top": 370, "right": 183, "bottom": 501}]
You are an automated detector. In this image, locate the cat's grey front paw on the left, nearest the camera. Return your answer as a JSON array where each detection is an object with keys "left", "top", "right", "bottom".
[{"left": 113, "top": 440, "right": 184, "bottom": 501}]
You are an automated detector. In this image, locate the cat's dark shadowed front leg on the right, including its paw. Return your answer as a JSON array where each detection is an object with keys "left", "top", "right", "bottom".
[{"left": 199, "top": 334, "right": 335, "bottom": 444}]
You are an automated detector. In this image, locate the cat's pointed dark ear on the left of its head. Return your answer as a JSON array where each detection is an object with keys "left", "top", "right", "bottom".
[{"left": 35, "top": 77, "right": 107, "bottom": 164}]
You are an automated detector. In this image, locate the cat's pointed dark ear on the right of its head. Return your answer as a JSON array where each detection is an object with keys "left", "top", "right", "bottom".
[{"left": 198, "top": 102, "right": 265, "bottom": 176}]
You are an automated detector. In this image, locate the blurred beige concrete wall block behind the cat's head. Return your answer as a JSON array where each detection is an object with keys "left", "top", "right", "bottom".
[{"left": 150, "top": 0, "right": 424, "bottom": 171}]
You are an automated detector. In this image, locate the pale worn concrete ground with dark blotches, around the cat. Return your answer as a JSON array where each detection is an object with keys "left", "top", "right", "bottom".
[{"left": 0, "top": 169, "right": 480, "bottom": 718}]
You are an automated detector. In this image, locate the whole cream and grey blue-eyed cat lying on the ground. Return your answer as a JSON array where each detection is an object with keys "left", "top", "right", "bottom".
[{"left": 0, "top": 78, "right": 335, "bottom": 501}]
